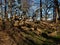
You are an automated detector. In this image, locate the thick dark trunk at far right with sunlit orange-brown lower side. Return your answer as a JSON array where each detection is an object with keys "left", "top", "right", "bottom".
[{"left": 53, "top": 0, "right": 59, "bottom": 23}]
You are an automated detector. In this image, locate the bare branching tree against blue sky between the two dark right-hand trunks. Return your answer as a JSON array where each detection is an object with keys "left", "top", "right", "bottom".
[{"left": 42, "top": 0, "right": 53, "bottom": 21}]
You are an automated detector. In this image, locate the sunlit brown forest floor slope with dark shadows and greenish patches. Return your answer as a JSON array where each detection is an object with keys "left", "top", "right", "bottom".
[{"left": 0, "top": 21, "right": 60, "bottom": 45}]
